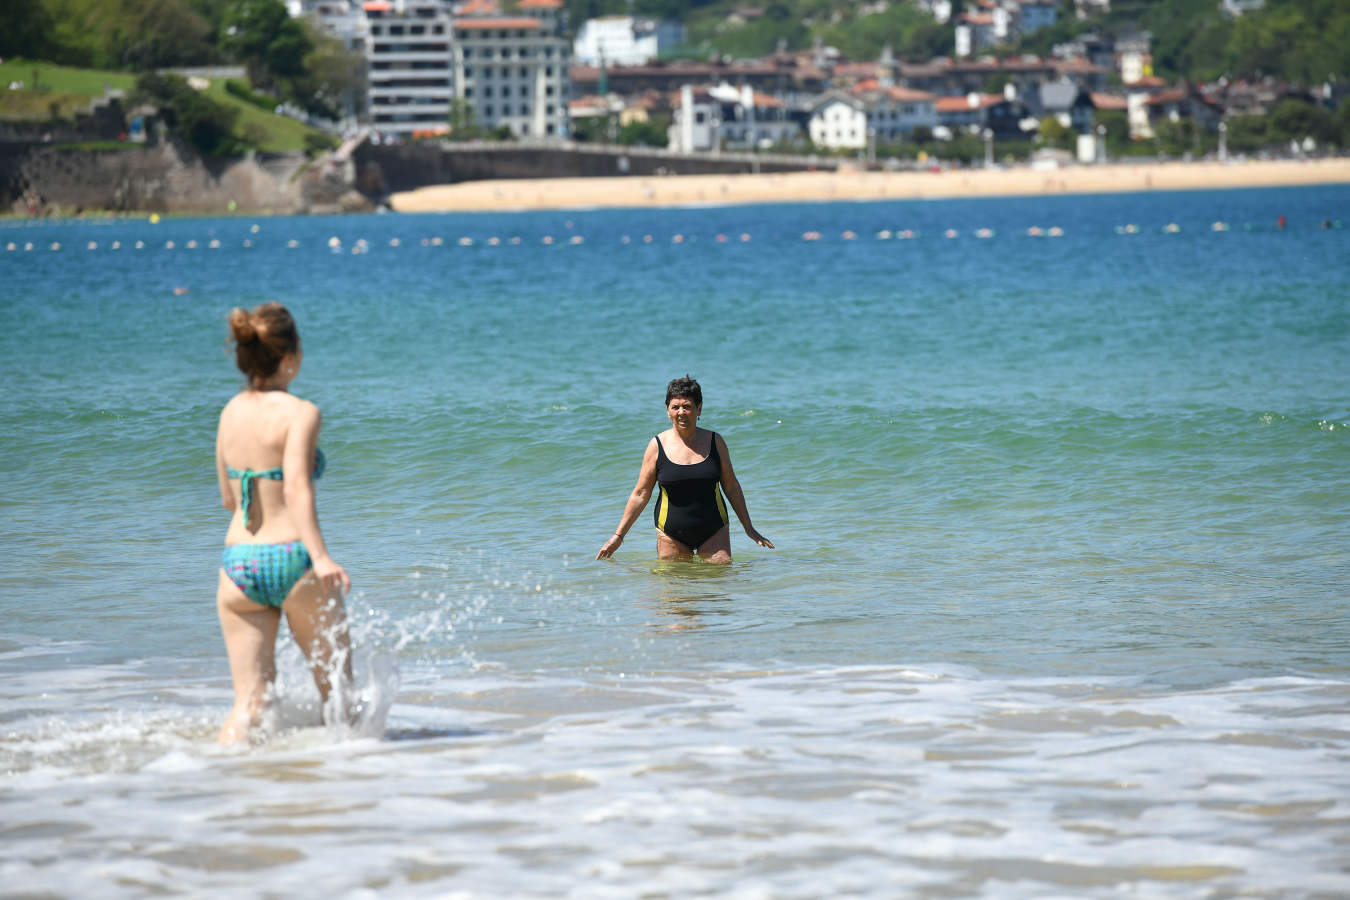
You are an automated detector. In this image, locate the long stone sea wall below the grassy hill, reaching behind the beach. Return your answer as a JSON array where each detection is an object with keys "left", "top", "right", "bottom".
[{"left": 0, "top": 138, "right": 837, "bottom": 215}]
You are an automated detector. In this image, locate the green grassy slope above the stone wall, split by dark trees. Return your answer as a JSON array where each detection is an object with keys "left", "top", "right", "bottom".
[{"left": 0, "top": 59, "right": 324, "bottom": 151}]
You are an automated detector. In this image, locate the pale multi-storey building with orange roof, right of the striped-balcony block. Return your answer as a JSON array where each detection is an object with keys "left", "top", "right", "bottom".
[{"left": 452, "top": 0, "right": 571, "bottom": 138}]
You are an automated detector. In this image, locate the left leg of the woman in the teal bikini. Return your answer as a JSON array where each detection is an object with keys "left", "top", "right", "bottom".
[{"left": 216, "top": 569, "right": 281, "bottom": 743}]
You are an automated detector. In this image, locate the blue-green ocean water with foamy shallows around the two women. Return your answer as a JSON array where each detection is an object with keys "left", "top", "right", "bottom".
[{"left": 0, "top": 186, "right": 1350, "bottom": 899}]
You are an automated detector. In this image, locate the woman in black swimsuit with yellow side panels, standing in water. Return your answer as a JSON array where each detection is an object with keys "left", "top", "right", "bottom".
[{"left": 595, "top": 375, "right": 774, "bottom": 564}]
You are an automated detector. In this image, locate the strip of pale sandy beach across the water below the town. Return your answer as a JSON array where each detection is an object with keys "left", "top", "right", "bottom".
[{"left": 390, "top": 158, "right": 1350, "bottom": 212}]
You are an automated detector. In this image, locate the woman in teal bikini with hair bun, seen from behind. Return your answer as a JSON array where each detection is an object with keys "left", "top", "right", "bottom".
[{"left": 216, "top": 302, "right": 351, "bottom": 743}]
